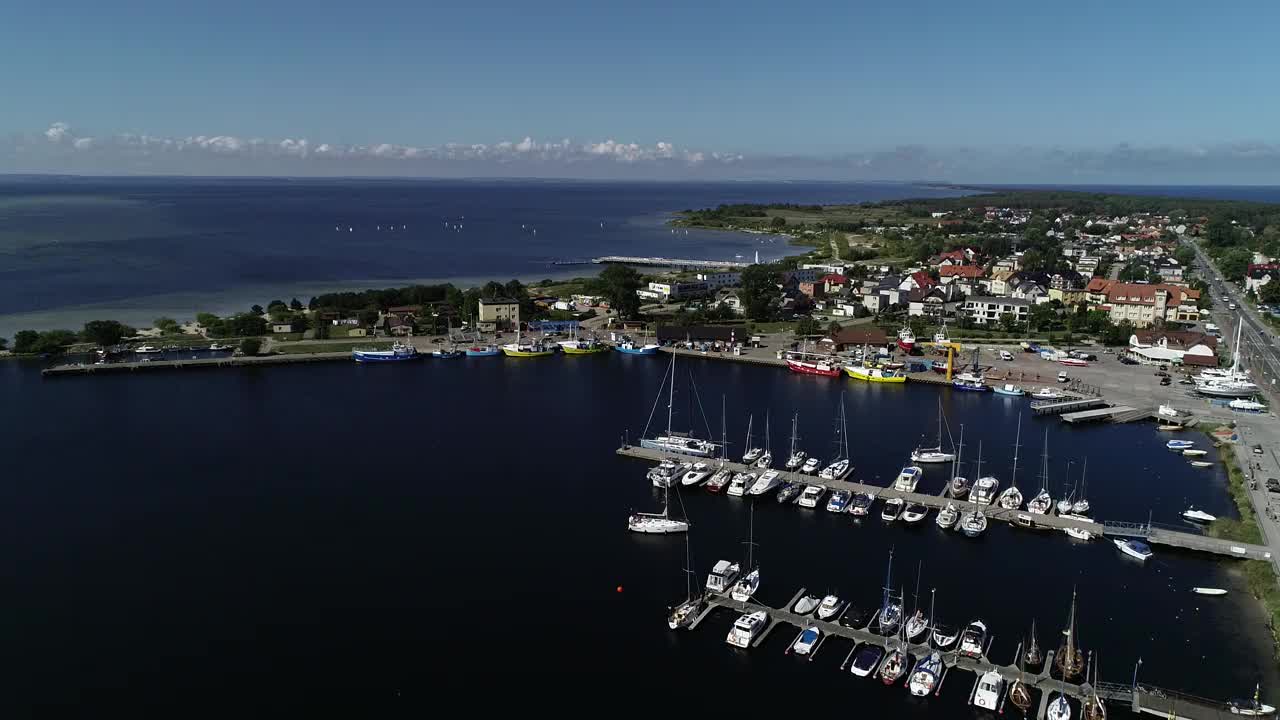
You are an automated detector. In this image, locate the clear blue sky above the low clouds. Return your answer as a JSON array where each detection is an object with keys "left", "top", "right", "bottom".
[{"left": 0, "top": 0, "right": 1280, "bottom": 182}]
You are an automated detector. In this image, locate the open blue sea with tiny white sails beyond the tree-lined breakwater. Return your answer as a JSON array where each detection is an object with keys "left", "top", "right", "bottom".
[{"left": 0, "top": 178, "right": 959, "bottom": 337}]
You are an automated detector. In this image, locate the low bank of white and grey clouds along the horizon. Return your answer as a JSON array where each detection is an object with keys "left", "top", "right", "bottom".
[{"left": 0, "top": 122, "right": 1280, "bottom": 184}]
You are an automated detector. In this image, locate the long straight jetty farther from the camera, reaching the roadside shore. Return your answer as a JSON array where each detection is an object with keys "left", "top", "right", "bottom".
[{"left": 617, "top": 445, "right": 1271, "bottom": 560}]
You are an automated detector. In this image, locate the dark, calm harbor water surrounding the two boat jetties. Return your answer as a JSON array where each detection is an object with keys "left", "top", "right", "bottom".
[{"left": 0, "top": 354, "right": 1277, "bottom": 702}]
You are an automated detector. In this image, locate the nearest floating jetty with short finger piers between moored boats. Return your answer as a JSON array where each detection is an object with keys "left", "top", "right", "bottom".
[{"left": 689, "top": 588, "right": 1239, "bottom": 720}]
